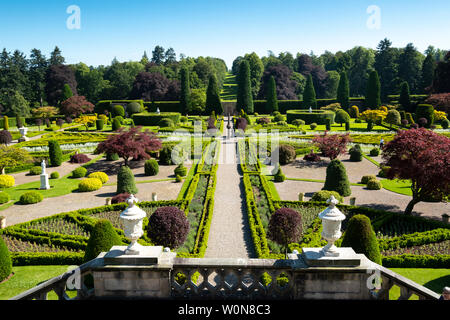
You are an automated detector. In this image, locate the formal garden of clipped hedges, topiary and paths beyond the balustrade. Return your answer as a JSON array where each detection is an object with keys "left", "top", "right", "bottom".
[{"left": 0, "top": 43, "right": 450, "bottom": 299}]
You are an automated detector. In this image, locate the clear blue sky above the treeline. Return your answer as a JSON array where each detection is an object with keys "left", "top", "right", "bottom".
[{"left": 0, "top": 0, "right": 450, "bottom": 67}]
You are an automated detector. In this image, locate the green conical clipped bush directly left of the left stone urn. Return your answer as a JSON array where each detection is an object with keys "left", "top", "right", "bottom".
[{"left": 84, "top": 219, "right": 122, "bottom": 262}]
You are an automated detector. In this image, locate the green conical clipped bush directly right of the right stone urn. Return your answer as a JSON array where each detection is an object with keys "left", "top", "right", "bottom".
[{"left": 341, "top": 214, "right": 381, "bottom": 264}]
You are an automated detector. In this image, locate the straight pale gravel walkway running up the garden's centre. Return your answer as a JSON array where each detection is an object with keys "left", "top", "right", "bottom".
[{"left": 205, "top": 120, "right": 256, "bottom": 258}]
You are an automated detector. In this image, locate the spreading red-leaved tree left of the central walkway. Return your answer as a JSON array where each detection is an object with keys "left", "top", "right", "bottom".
[{"left": 97, "top": 127, "right": 162, "bottom": 166}]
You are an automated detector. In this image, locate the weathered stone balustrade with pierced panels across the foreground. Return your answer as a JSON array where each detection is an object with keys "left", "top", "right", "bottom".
[{"left": 12, "top": 247, "right": 439, "bottom": 300}]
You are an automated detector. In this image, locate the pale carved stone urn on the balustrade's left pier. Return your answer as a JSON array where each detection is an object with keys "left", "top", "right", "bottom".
[{"left": 120, "top": 195, "right": 146, "bottom": 255}]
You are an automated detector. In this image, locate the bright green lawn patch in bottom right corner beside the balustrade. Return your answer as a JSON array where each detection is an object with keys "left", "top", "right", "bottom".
[{"left": 389, "top": 268, "right": 450, "bottom": 300}]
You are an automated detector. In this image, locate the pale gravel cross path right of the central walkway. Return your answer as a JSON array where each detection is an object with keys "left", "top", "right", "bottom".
[{"left": 275, "top": 180, "right": 450, "bottom": 220}]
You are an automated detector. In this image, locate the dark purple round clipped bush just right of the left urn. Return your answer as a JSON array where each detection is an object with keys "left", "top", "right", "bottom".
[{"left": 147, "top": 207, "right": 189, "bottom": 249}]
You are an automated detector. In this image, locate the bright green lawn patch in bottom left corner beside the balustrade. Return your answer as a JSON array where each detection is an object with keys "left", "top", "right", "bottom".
[{"left": 0, "top": 266, "right": 73, "bottom": 300}]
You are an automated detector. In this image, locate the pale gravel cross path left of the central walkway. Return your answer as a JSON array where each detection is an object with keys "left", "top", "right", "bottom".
[{"left": 1, "top": 181, "right": 182, "bottom": 226}]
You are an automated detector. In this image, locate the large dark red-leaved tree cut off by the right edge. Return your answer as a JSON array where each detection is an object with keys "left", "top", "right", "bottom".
[{"left": 383, "top": 128, "right": 450, "bottom": 214}]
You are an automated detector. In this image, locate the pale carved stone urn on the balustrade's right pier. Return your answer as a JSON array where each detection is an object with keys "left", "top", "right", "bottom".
[{"left": 319, "top": 196, "right": 345, "bottom": 257}]
